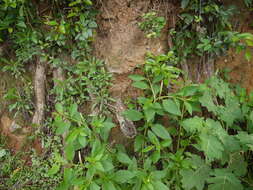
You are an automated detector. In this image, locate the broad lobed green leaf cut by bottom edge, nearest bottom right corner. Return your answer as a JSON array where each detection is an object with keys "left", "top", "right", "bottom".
[{"left": 207, "top": 169, "right": 244, "bottom": 190}]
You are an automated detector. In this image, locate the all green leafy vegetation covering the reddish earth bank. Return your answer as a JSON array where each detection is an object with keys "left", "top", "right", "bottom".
[{"left": 0, "top": 0, "right": 253, "bottom": 190}]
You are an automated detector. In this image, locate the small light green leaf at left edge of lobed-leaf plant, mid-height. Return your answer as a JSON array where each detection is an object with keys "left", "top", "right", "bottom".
[{"left": 181, "top": 116, "right": 204, "bottom": 134}]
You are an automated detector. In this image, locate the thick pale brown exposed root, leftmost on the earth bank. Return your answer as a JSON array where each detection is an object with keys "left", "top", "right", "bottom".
[{"left": 32, "top": 57, "right": 46, "bottom": 126}]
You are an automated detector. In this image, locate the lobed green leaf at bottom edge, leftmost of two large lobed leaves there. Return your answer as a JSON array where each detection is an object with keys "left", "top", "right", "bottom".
[{"left": 180, "top": 155, "right": 211, "bottom": 190}]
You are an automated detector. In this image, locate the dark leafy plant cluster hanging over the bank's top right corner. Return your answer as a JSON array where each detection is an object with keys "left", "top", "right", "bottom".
[{"left": 173, "top": 0, "right": 253, "bottom": 60}]
